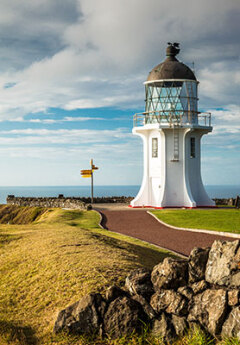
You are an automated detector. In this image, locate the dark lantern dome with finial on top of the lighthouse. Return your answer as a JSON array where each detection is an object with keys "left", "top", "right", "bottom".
[{"left": 147, "top": 43, "right": 196, "bottom": 82}]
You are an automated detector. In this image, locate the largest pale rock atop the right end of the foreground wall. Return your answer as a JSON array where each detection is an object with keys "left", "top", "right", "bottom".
[{"left": 205, "top": 240, "right": 240, "bottom": 287}]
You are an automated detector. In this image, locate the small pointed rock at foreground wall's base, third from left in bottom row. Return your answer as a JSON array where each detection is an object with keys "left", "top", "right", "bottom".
[{"left": 152, "top": 313, "right": 175, "bottom": 341}]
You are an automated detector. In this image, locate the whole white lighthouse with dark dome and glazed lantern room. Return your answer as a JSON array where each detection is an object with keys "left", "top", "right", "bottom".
[{"left": 130, "top": 43, "right": 215, "bottom": 208}]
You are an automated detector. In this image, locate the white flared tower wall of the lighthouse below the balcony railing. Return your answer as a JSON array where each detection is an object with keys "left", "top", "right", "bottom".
[{"left": 131, "top": 125, "right": 214, "bottom": 207}]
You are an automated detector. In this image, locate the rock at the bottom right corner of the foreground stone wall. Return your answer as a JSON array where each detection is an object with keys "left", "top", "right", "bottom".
[{"left": 221, "top": 307, "right": 240, "bottom": 339}]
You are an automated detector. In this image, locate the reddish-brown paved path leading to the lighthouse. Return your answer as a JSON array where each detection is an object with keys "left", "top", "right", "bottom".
[{"left": 94, "top": 205, "right": 236, "bottom": 255}]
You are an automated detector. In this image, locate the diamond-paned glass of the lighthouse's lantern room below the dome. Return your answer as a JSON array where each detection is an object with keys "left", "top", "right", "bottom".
[{"left": 145, "top": 80, "right": 198, "bottom": 123}]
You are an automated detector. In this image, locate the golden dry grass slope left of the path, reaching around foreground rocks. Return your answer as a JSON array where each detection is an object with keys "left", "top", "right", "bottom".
[{"left": 0, "top": 206, "right": 239, "bottom": 345}]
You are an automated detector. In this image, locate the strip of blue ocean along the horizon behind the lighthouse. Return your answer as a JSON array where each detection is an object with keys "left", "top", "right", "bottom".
[{"left": 0, "top": 185, "right": 240, "bottom": 204}]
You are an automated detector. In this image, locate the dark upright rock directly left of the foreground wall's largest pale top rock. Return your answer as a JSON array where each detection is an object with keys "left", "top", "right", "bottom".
[{"left": 188, "top": 248, "right": 210, "bottom": 283}]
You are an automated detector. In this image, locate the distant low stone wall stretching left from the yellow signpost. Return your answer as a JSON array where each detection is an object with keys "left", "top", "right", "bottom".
[{"left": 6, "top": 195, "right": 91, "bottom": 210}]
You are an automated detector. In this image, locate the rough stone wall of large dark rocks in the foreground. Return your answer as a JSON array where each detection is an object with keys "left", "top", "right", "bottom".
[{"left": 54, "top": 240, "right": 240, "bottom": 341}]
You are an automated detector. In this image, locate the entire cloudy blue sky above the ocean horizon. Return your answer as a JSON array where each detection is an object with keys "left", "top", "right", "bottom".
[{"left": 0, "top": 0, "right": 240, "bottom": 186}]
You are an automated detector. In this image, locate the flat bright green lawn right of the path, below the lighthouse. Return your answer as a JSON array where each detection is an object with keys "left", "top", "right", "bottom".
[{"left": 151, "top": 209, "right": 240, "bottom": 234}]
